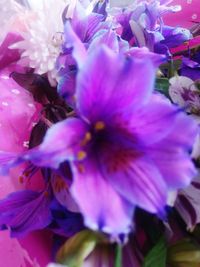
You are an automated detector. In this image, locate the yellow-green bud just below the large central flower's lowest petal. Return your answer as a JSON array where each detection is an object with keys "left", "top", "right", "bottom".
[{"left": 56, "top": 230, "right": 103, "bottom": 267}]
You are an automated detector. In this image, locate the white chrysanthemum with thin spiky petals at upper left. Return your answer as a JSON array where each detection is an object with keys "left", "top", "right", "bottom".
[{"left": 12, "top": 0, "right": 72, "bottom": 80}]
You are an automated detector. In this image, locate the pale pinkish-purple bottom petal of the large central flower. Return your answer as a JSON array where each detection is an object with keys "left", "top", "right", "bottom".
[{"left": 71, "top": 158, "right": 133, "bottom": 236}]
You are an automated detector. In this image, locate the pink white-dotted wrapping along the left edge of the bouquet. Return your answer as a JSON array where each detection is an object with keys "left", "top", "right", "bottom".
[{"left": 0, "top": 66, "right": 51, "bottom": 267}]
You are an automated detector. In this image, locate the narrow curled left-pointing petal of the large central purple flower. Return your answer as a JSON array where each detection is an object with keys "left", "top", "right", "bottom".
[{"left": 28, "top": 118, "right": 87, "bottom": 168}]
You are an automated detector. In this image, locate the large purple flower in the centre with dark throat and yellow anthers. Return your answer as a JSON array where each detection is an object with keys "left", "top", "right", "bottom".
[{"left": 22, "top": 47, "right": 196, "bottom": 239}]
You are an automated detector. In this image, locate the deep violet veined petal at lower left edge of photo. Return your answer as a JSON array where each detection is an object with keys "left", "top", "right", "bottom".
[{"left": 0, "top": 190, "right": 51, "bottom": 237}]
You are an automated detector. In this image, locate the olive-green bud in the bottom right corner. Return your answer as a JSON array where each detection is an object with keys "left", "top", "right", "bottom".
[{"left": 167, "top": 239, "right": 200, "bottom": 267}]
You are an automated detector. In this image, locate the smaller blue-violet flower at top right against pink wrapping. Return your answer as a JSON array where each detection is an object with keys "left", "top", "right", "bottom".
[{"left": 117, "top": 1, "right": 191, "bottom": 54}]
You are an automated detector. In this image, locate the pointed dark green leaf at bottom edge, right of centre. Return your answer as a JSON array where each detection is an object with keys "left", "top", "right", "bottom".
[{"left": 142, "top": 237, "right": 167, "bottom": 267}]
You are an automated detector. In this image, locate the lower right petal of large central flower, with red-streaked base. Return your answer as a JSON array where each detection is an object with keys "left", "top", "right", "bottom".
[{"left": 101, "top": 151, "right": 167, "bottom": 213}]
